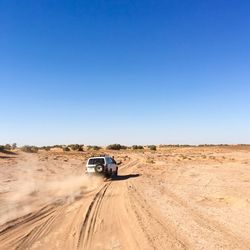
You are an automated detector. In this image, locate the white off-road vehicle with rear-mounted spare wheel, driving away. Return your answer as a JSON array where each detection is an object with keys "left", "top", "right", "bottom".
[{"left": 86, "top": 156, "right": 118, "bottom": 176}]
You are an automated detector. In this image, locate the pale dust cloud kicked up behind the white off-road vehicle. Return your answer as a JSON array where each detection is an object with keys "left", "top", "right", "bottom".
[{"left": 0, "top": 156, "right": 103, "bottom": 225}]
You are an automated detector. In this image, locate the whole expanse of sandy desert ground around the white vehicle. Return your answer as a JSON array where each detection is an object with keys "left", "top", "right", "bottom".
[{"left": 0, "top": 147, "right": 250, "bottom": 249}]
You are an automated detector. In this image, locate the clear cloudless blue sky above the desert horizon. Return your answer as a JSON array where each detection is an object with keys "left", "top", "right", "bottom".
[{"left": 0, "top": 0, "right": 250, "bottom": 145}]
